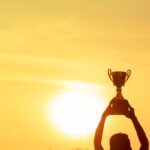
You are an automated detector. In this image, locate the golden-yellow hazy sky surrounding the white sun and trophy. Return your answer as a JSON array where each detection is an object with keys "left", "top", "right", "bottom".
[{"left": 0, "top": 0, "right": 150, "bottom": 150}]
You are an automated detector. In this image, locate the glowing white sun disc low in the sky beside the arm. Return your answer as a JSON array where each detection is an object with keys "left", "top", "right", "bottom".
[{"left": 48, "top": 82, "right": 105, "bottom": 137}]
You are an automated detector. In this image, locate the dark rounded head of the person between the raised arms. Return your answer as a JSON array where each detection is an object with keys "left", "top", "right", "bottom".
[{"left": 110, "top": 133, "right": 132, "bottom": 150}]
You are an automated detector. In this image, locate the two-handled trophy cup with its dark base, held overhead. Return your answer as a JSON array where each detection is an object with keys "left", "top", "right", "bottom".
[{"left": 108, "top": 69, "right": 131, "bottom": 115}]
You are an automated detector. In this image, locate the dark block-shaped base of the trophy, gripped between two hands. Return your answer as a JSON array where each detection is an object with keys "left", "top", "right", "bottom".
[{"left": 111, "top": 98, "right": 129, "bottom": 115}]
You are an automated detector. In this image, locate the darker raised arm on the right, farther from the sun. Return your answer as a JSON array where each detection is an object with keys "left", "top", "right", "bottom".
[{"left": 126, "top": 105, "right": 149, "bottom": 150}]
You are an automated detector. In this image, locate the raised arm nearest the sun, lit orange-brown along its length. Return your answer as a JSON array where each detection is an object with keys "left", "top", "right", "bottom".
[{"left": 94, "top": 104, "right": 111, "bottom": 150}]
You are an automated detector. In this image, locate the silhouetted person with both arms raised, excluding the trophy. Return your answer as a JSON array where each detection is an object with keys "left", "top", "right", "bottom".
[{"left": 94, "top": 101, "right": 149, "bottom": 150}]
